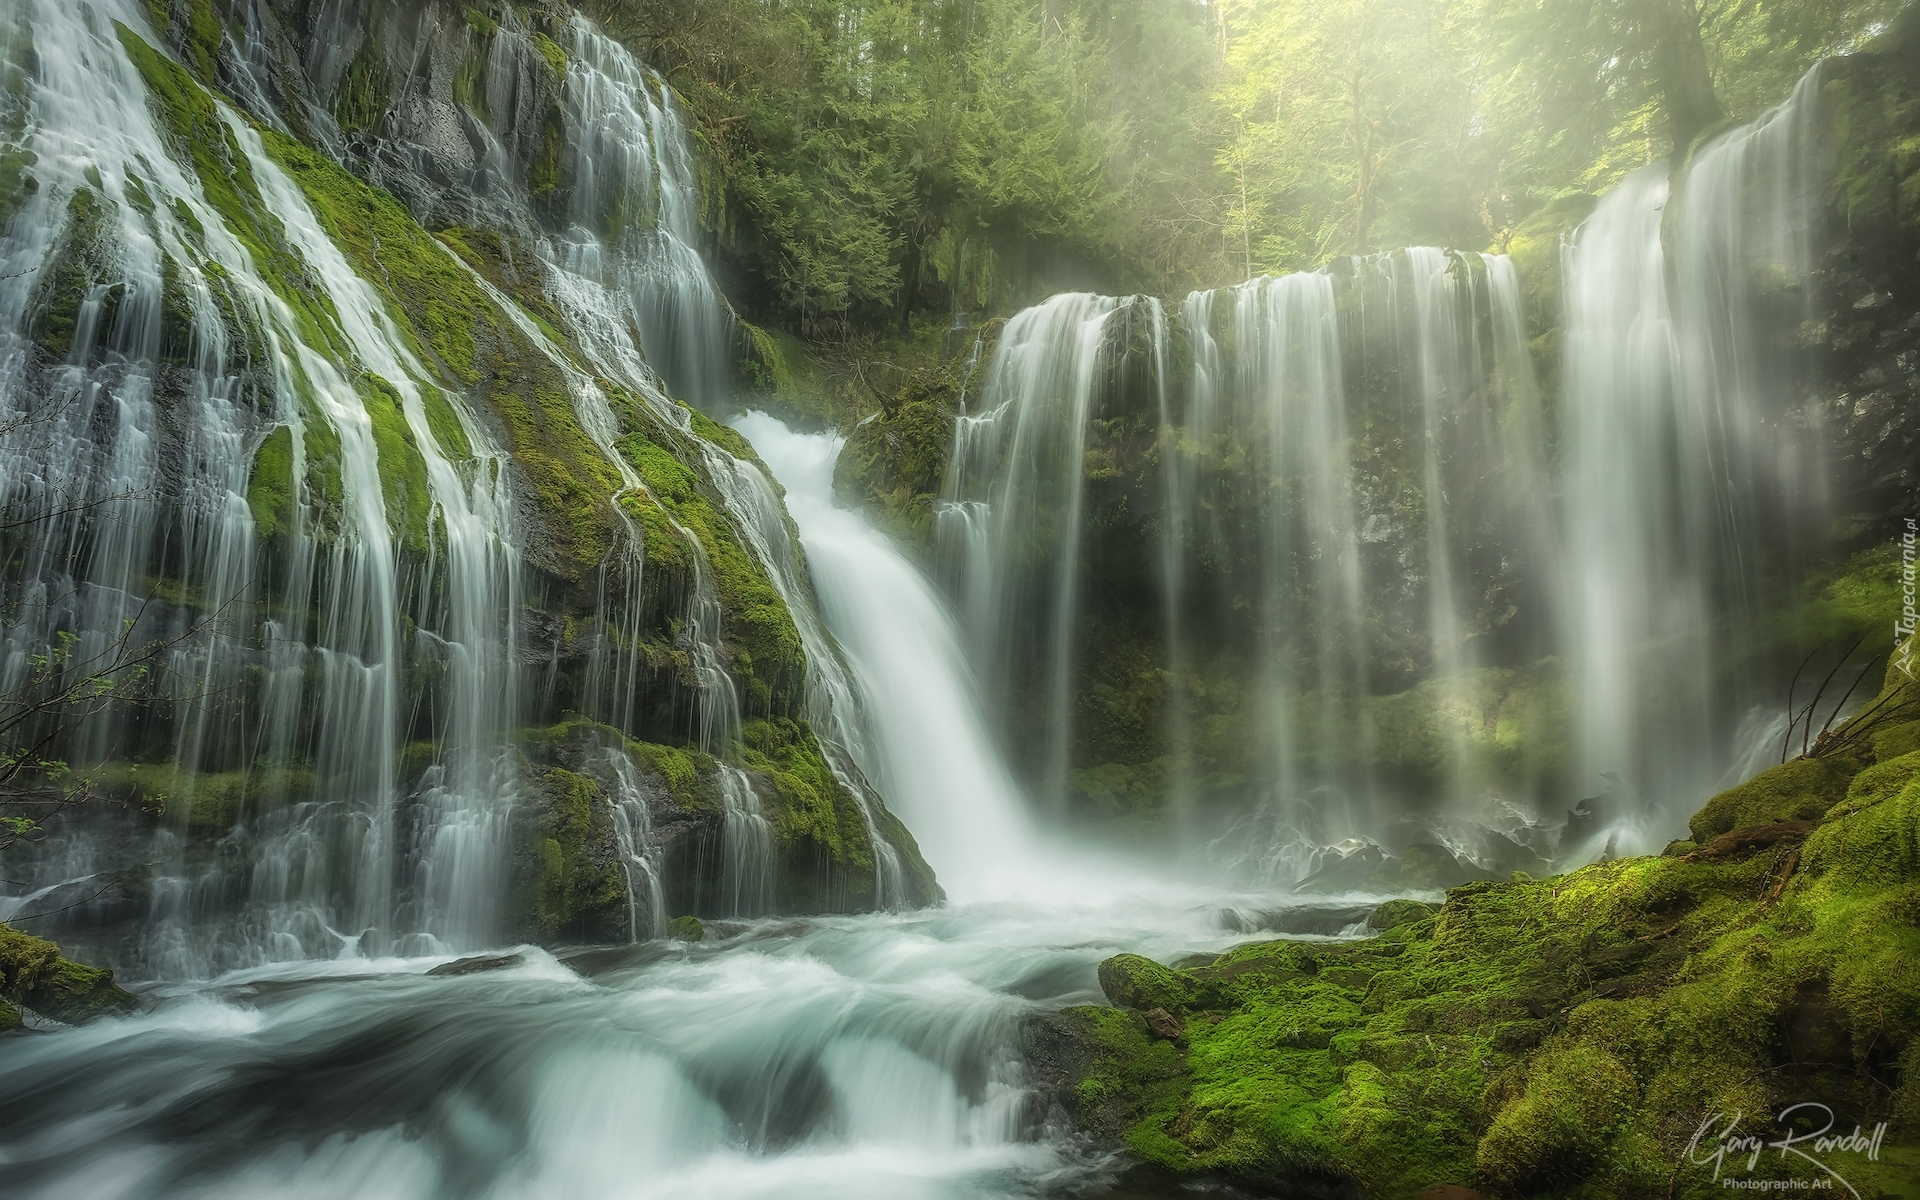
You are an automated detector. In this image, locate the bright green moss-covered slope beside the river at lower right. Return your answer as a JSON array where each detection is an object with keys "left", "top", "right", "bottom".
[{"left": 1037, "top": 685, "right": 1920, "bottom": 1198}]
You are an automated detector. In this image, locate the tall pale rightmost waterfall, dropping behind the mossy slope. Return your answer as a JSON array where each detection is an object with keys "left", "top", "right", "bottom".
[{"left": 1565, "top": 67, "right": 1830, "bottom": 851}]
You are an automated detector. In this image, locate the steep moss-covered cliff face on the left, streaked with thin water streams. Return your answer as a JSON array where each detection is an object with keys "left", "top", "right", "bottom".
[{"left": 4, "top": 0, "right": 939, "bottom": 970}]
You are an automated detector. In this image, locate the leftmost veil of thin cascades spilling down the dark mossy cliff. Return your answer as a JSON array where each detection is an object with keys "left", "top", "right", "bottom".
[{"left": 6, "top": 6, "right": 516, "bottom": 973}]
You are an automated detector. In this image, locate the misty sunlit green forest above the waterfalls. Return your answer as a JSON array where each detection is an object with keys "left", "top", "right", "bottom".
[{"left": 588, "top": 0, "right": 1899, "bottom": 340}]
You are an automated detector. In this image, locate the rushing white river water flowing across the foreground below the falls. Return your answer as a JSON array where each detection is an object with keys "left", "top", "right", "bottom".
[{"left": 0, "top": 887, "right": 1382, "bottom": 1200}]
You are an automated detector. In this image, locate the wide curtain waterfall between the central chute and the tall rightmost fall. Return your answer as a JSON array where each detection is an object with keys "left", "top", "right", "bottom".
[{"left": 941, "top": 248, "right": 1555, "bottom": 881}]
